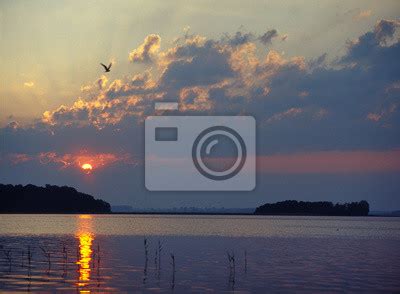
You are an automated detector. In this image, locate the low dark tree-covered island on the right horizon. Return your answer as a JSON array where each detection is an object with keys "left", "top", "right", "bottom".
[{"left": 254, "top": 200, "right": 369, "bottom": 216}]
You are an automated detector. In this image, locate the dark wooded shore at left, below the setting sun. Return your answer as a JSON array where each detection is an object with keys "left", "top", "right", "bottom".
[{"left": 0, "top": 184, "right": 111, "bottom": 213}]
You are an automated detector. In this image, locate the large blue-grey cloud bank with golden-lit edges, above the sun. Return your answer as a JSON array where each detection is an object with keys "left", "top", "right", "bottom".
[{"left": 1, "top": 20, "right": 400, "bottom": 154}]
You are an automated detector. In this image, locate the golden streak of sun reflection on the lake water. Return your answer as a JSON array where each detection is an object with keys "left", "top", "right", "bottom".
[{"left": 76, "top": 215, "right": 95, "bottom": 293}]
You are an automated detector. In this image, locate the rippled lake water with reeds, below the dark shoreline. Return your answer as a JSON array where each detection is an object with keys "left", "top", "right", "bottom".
[{"left": 0, "top": 215, "right": 400, "bottom": 293}]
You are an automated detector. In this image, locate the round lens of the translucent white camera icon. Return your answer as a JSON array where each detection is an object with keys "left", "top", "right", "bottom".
[{"left": 192, "top": 126, "right": 246, "bottom": 181}]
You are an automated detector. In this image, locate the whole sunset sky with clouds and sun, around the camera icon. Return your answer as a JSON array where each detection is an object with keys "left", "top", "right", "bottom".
[{"left": 0, "top": 0, "right": 400, "bottom": 210}]
